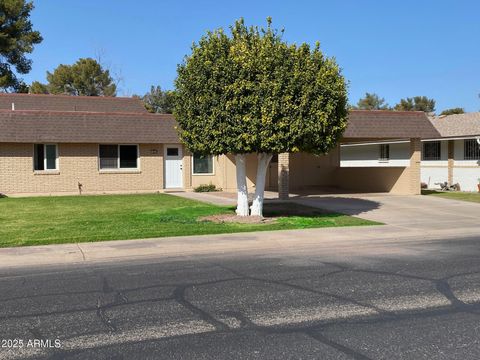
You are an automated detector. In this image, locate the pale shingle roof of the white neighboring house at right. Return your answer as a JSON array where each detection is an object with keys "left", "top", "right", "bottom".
[{"left": 430, "top": 112, "right": 480, "bottom": 137}]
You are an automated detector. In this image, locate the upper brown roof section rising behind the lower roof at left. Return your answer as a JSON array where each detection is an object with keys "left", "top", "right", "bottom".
[{"left": 0, "top": 94, "right": 147, "bottom": 113}]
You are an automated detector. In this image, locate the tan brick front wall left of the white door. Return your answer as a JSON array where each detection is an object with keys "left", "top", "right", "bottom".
[{"left": 0, "top": 143, "right": 163, "bottom": 195}]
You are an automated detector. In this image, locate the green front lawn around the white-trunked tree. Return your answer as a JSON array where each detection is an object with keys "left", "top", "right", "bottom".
[{"left": 0, "top": 194, "right": 377, "bottom": 247}]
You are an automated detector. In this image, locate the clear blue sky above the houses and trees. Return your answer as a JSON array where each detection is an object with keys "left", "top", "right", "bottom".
[{"left": 25, "top": 0, "right": 480, "bottom": 113}]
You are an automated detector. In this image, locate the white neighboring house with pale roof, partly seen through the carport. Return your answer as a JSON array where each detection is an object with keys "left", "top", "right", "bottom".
[{"left": 341, "top": 113, "right": 480, "bottom": 191}]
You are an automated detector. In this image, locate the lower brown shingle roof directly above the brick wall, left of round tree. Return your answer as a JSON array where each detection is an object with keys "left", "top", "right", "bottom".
[{"left": 0, "top": 110, "right": 179, "bottom": 144}]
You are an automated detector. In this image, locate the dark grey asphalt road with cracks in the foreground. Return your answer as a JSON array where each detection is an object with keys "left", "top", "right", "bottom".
[{"left": 0, "top": 237, "right": 480, "bottom": 360}]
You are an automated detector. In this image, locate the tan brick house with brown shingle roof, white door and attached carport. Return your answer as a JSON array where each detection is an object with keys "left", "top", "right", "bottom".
[{"left": 0, "top": 94, "right": 441, "bottom": 198}]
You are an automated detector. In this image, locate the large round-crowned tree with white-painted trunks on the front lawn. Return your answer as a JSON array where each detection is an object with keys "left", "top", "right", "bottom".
[{"left": 174, "top": 18, "right": 348, "bottom": 216}]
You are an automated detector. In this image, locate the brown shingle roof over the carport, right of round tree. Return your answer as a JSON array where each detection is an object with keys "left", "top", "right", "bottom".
[{"left": 343, "top": 110, "right": 440, "bottom": 139}]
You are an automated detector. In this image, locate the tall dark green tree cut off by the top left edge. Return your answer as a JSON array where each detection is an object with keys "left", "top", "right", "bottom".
[{"left": 0, "top": 0, "right": 43, "bottom": 91}]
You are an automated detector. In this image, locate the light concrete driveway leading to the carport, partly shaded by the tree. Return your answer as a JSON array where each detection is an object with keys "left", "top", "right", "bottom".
[{"left": 293, "top": 194, "right": 480, "bottom": 230}]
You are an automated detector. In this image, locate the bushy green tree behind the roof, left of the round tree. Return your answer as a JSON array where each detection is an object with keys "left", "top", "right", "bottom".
[{"left": 30, "top": 58, "right": 117, "bottom": 96}]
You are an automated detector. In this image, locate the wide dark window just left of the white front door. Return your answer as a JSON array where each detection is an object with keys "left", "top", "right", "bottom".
[{"left": 99, "top": 145, "right": 138, "bottom": 170}]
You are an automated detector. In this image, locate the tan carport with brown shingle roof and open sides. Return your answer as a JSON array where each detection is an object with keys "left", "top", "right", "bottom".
[{"left": 267, "top": 110, "right": 439, "bottom": 199}]
